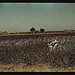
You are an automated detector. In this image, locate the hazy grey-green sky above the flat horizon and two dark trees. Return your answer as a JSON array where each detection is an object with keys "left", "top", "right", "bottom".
[{"left": 0, "top": 3, "right": 75, "bottom": 32}]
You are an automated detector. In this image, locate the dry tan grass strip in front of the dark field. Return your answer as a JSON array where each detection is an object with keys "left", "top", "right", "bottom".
[{"left": 0, "top": 63, "right": 75, "bottom": 72}]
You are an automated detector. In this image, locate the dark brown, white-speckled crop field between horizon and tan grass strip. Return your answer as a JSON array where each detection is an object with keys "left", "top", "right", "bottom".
[{"left": 0, "top": 34, "right": 75, "bottom": 71}]
